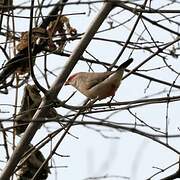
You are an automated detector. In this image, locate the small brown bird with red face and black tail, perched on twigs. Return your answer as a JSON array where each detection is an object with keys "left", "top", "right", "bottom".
[{"left": 65, "top": 58, "right": 133, "bottom": 100}]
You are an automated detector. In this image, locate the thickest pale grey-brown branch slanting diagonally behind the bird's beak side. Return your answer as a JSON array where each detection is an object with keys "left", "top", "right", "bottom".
[{"left": 0, "top": 2, "right": 113, "bottom": 180}]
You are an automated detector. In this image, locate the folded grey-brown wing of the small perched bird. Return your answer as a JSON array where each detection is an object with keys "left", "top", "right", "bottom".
[{"left": 79, "top": 71, "right": 113, "bottom": 89}]
